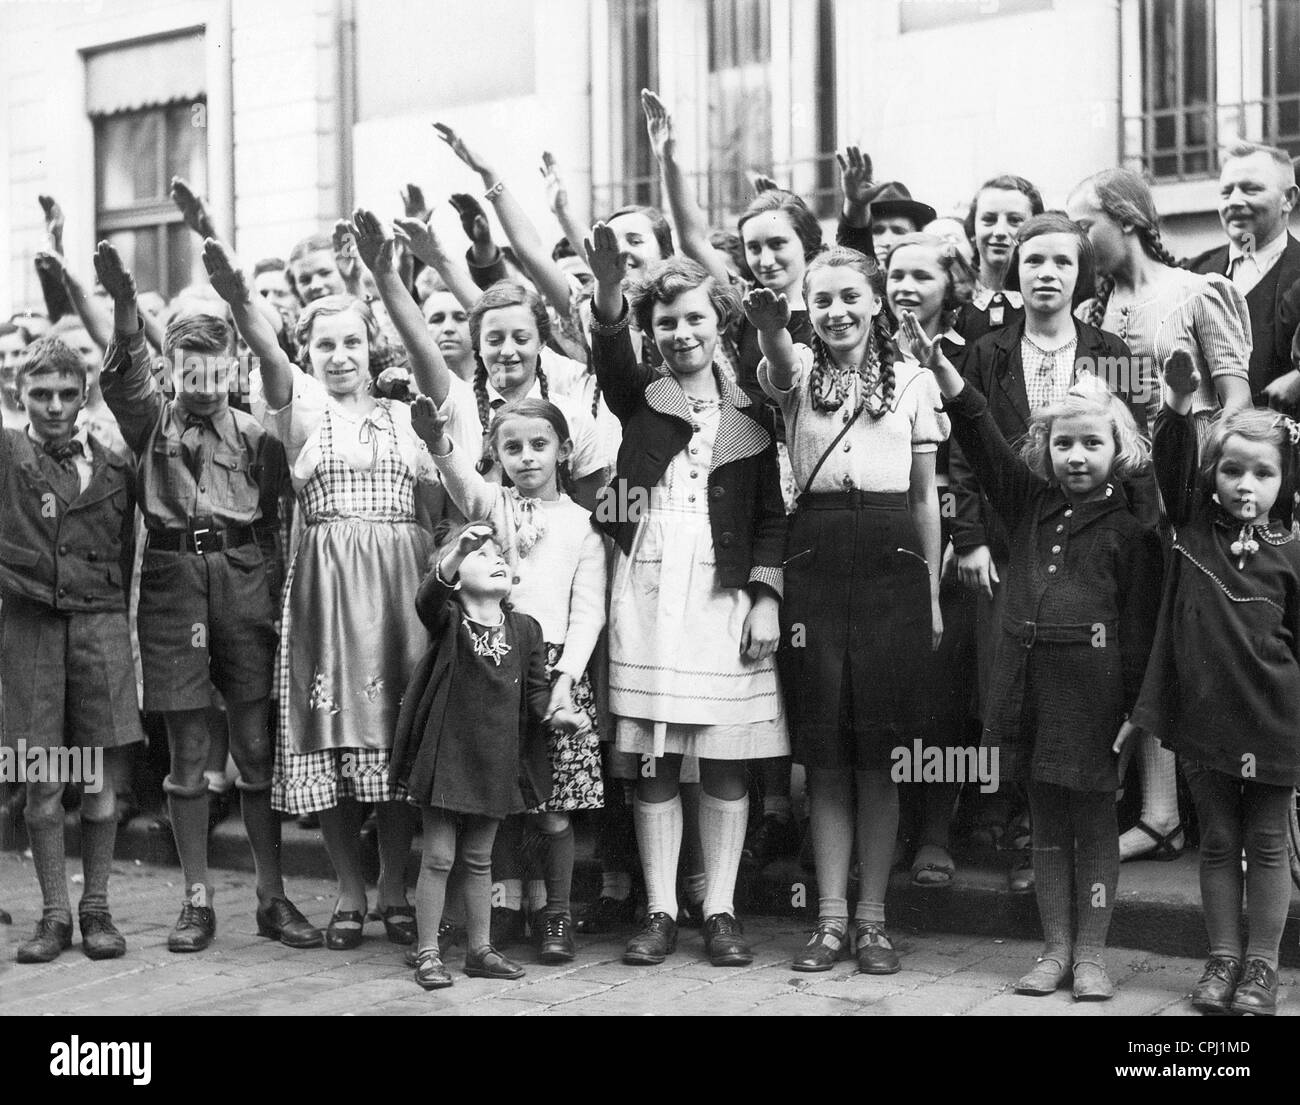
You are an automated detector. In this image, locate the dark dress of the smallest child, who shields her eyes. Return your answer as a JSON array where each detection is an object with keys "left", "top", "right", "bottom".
[{"left": 389, "top": 572, "right": 551, "bottom": 818}]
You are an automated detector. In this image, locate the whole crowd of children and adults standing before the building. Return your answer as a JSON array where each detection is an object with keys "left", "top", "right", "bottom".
[{"left": 0, "top": 91, "right": 1300, "bottom": 1014}]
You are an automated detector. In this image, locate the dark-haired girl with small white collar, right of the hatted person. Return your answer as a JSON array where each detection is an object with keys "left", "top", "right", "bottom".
[{"left": 957, "top": 173, "right": 1043, "bottom": 345}]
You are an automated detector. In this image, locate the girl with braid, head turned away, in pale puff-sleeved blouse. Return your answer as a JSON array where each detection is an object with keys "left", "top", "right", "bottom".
[{"left": 1069, "top": 169, "right": 1251, "bottom": 859}]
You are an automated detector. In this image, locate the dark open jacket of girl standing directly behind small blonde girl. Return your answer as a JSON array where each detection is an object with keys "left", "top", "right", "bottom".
[{"left": 948, "top": 315, "right": 1158, "bottom": 563}]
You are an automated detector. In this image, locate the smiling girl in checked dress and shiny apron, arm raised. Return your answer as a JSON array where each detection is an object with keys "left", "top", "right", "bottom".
[{"left": 204, "top": 239, "right": 437, "bottom": 949}]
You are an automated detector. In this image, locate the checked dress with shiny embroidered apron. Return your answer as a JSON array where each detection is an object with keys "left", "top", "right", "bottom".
[{"left": 272, "top": 403, "right": 432, "bottom": 814}]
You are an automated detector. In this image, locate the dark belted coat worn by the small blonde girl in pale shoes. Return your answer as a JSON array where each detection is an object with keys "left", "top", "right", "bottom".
[{"left": 945, "top": 384, "right": 1161, "bottom": 790}]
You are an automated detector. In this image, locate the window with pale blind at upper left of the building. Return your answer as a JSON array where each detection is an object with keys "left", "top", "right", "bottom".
[{"left": 86, "top": 31, "right": 208, "bottom": 296}]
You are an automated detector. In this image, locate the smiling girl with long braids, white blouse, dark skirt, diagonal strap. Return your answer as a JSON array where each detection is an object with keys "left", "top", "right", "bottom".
[{"left": 745, "top": 247, "right": 948, "bottom": 974}]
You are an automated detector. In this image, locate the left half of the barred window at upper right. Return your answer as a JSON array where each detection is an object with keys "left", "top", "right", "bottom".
[{"left": 1140, "top": 0, "right": 1218, "bottom": 179}]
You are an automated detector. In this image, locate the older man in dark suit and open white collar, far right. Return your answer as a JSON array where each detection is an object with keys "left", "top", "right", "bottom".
[{"left": 1192, "top": 142, "right": 1300, "bottom": 410}]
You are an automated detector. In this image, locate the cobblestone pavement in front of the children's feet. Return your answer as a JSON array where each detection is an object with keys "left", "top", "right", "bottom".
[{"left": 0, "top": 853, "right": 1300, "bottom": 1018}]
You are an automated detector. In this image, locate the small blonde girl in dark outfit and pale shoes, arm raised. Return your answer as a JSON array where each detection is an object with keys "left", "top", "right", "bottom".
[{"left": 920, "top": 313, "right": 1161, "bottom": 1001}]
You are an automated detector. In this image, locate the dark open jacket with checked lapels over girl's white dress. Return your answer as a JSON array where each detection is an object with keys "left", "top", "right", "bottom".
[{"left": 592, "top": 306, "right": 787, "bottom": 595}]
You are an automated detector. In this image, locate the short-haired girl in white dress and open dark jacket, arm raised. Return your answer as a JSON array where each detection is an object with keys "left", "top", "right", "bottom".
[{"left": 586, "top": 224, "right": 789, "bottom": 966}]
